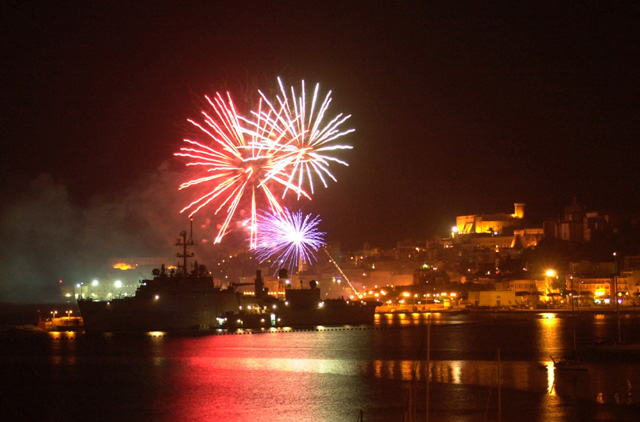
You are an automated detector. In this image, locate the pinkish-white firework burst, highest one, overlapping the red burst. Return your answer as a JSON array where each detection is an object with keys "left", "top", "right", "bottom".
[{"left": 253, "top": 78, "right": 354, "bottom": 198}]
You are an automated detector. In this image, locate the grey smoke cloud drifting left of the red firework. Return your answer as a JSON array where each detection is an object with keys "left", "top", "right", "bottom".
[{"left": 0, "top": 163, "right": 220, "bottom": 303}]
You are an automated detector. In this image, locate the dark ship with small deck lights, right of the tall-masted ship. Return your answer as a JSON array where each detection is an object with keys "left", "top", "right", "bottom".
[{"left": 222, "top": 270, "right": 380, "bottom": 329}]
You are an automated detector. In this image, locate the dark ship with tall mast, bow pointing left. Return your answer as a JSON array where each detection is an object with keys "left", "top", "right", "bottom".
[{"left": 78, "top": 221, "right": 240, "bottom": 331}]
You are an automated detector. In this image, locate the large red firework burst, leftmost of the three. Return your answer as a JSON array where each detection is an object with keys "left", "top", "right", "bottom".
[{"left": 174, "top": 93, "right": 309, "bottom": 248}]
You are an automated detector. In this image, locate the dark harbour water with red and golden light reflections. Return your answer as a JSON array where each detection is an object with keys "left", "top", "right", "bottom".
[{"left": 0, "top": 306, "right": 640, "bottom": 422}]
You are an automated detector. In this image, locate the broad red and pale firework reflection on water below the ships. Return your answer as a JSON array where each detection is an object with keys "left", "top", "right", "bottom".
[{"left": 158, "top": 342, "right": 358, "bottom": 421}]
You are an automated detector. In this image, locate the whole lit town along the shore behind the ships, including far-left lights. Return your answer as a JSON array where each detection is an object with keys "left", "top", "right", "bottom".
[{"left": 70, "top": 200, "right": 640, "bottom": 312}]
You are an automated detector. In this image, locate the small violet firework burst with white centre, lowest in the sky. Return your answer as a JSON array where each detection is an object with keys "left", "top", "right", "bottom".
[{"left": 256, "top": 208, "right": 325, "bottom": 273}]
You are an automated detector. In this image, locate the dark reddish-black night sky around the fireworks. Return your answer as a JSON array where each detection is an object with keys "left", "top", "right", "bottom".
[{"left": 0, "top": 1, "right": 640, "bottom": 300}]
